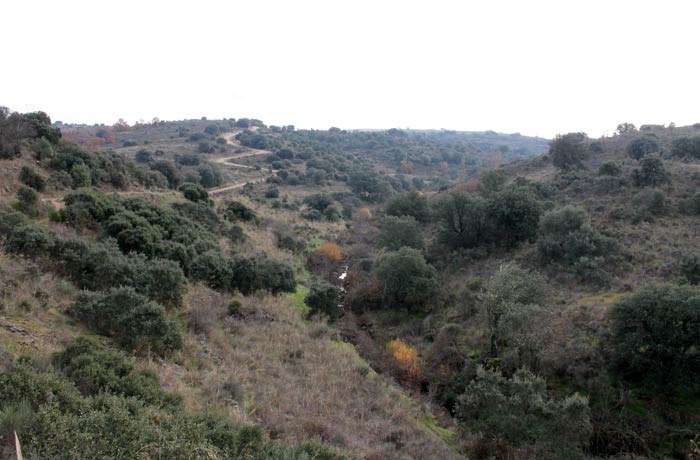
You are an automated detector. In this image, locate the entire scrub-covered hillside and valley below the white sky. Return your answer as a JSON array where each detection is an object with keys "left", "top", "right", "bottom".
[{"left": 0, "top": 106, "right": 700, "bottom": 459}]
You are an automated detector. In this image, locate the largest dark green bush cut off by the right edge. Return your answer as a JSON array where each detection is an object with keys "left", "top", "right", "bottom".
[{"left": 610, "top": 286, "right": 700, "bottom": 391}]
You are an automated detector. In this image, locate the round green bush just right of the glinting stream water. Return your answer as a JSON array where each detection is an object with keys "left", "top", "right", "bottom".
[{"left": 376, "top": 247, "right": 437, "bottom": 308}]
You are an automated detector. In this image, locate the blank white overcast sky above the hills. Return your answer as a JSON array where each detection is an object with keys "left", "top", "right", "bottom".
[{"left": 0, "top": 0, "right": 700, "bottom": 137}]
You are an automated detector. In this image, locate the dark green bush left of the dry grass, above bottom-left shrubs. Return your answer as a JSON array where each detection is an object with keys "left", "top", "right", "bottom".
[{"left": 68, "top": 287, "right": 182, "bottom": 354}]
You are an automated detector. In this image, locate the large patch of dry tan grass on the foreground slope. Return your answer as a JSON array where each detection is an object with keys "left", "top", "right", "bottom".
[{"left": 150, "top": 286, "right": 460, "bottom": 459}]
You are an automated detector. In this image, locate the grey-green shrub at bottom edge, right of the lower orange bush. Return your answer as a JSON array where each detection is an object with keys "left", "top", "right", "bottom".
[{"left": 456, "top": 367, "right": 592, "bottom": 460}]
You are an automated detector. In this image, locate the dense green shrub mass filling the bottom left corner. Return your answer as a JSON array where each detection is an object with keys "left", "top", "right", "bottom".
[{"left": 0, "top": 344, "right": 346, "bottom": 460}]
